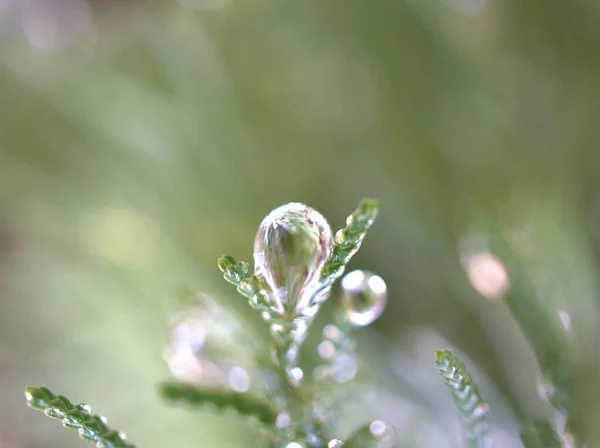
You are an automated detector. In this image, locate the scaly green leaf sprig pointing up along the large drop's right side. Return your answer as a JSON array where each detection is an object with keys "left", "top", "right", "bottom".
[{"left": 321, "top": 198, "right": 379, "bottom": 283}]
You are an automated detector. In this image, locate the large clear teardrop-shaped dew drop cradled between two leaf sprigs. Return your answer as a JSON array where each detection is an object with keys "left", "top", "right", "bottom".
[{"left": 254, "top": 203, "right": 333, "bottom": 316}]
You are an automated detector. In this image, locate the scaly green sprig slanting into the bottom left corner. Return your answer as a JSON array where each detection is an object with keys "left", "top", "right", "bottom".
[{"left": 25, "top": 387, "right": 135, "bottom": 448}]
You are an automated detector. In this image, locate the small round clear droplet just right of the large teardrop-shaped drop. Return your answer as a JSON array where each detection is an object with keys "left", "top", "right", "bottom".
[{"left": 342, "top": 271, "right": 387, "bottom": 327}]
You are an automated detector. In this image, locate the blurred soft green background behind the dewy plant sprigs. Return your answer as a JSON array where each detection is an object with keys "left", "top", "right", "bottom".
[{"left": 0, "top": 0, "right": 600, "bottom": 448}]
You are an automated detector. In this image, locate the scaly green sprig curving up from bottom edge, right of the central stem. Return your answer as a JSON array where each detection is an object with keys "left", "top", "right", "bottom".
[{"left": 435, "top": 350, "right": 491, "bottom": 448}]
